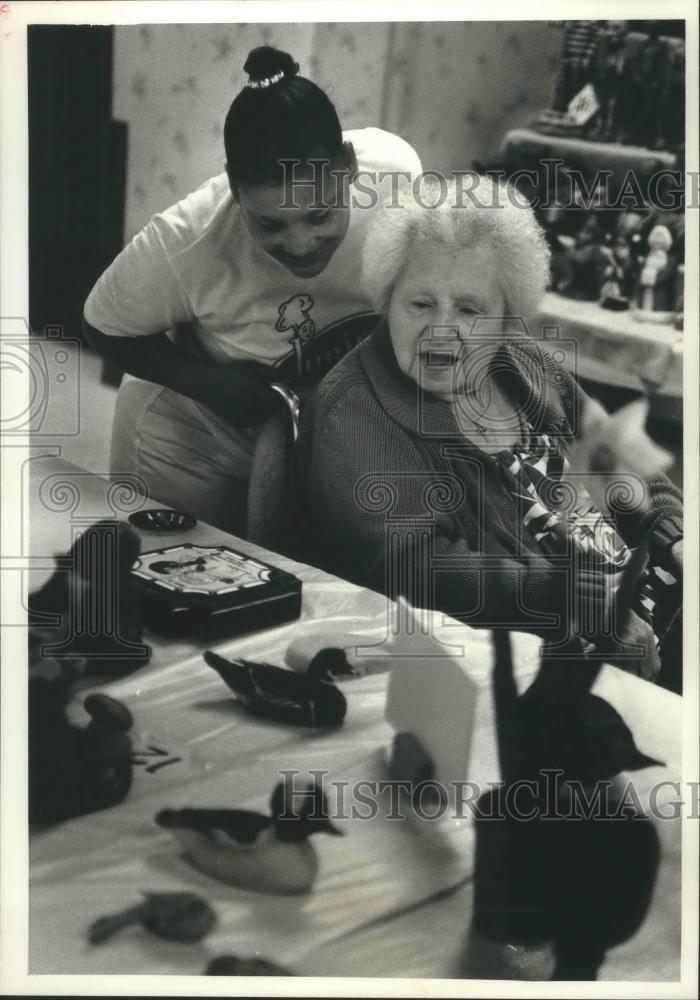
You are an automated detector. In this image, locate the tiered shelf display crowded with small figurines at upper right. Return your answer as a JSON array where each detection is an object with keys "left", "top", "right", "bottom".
[{"left": 474, "top": 20, "right": 685, "bottom": 396}]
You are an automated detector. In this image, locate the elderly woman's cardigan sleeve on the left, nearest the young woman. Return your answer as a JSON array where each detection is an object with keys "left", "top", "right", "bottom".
[{"left": 302, "top": 372, "right": 568, "bottom": 637}]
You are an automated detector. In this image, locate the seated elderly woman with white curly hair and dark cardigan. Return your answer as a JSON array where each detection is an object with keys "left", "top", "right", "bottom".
[{"left": 301, "top": 178, "right": 683, "bottom": 676}]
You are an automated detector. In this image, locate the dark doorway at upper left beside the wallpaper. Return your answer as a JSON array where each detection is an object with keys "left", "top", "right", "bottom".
[{"left": 27, "top": 25, "right": 127, "bottom": 337}]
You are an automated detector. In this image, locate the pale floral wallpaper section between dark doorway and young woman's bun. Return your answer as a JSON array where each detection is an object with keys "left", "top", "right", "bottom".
[{"left": 112, "top": 24, "right": 313, "bottom": 240}]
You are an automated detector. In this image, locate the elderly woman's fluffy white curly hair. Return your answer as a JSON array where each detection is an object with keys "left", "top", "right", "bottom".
[{"left": 362, "top": 174, "right": 550, "bottom": 320}]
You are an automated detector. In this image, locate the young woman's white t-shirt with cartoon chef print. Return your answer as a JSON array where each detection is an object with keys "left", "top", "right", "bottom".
[{"left": 85, "top": 128, "right": 421, "bottom": 374}]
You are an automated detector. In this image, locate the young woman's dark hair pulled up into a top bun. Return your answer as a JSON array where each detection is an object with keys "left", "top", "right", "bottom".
[{"left": 224, "top": 45, "right": 343, "bottom": 187}]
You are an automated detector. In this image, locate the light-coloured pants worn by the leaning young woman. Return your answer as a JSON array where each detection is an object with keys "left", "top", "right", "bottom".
[{"left": 109, "top": 375, "right": 257, "bottom": 536}]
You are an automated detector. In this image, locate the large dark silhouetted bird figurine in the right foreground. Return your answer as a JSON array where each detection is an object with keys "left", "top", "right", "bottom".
[{"left": 474, "top": 632, "right": 659, "bottom": 980}]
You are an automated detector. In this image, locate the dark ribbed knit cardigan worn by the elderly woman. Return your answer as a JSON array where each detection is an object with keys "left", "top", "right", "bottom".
[{"left": 299, "top": 321, "right": 683, "bottom": 636}]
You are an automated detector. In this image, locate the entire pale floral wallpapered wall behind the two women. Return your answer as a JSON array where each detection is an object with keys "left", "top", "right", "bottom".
[{"left": 113, "top": 21, "right": 561, "bottom": 241}]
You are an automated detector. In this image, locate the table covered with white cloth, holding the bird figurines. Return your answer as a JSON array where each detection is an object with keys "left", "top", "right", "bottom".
[{"left": 25, "top": 457, "right": 681, "bottom": 981}]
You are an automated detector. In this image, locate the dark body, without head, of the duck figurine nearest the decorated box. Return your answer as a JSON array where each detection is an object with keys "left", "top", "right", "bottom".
[{"left": 204, "top": 650, "right": 347, "bottom": 727}]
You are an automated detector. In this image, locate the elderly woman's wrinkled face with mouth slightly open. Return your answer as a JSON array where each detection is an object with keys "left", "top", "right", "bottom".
[{"left": 388, "top": 242, "right": 504, "bottom": 399}]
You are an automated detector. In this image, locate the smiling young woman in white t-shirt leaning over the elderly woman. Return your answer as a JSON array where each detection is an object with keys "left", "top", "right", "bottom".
[{"left": 85, "top": 47, "right": 421, "bottom": 534}]
